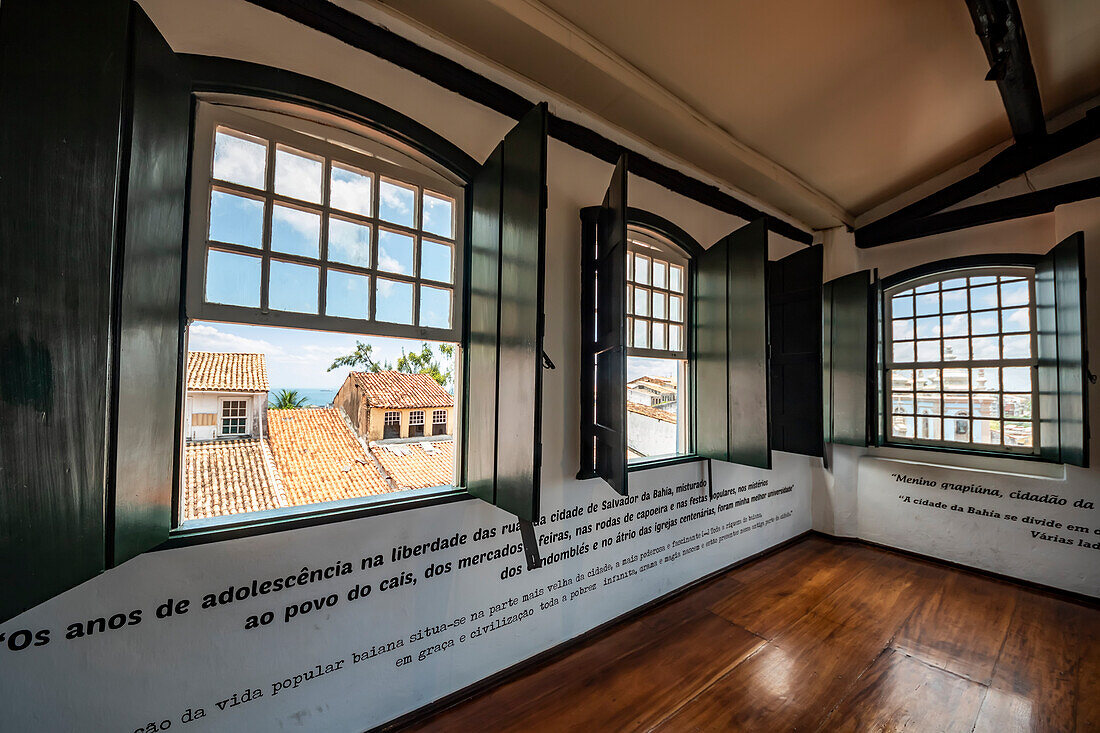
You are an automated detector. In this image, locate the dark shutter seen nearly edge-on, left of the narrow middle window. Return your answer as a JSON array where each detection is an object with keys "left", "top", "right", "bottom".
[{"left": 594, "top": 153, "right": 628, "bottom": 496}]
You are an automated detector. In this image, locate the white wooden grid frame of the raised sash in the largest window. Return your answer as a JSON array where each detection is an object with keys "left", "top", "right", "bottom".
[{"left": 186, "top": 101, "right": 465, "bottom": 343}]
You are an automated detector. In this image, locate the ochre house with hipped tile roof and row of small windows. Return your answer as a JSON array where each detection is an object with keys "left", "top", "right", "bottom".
[{"left": 332, "top": 372, "right": 454, "bottom": 440}]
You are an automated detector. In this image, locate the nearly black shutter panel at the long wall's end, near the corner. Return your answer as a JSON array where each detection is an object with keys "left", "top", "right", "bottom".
[{"left": 768, "top": 247, "right": 823, "bottom": 456}]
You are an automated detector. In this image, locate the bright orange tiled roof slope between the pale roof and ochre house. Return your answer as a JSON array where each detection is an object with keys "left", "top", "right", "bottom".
[{"left": 267, "top": 407, "right": 395, "bottom": 506}]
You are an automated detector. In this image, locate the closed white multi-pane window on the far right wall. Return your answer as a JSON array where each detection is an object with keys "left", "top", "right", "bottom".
[{"left": 883, "top": 267, "right": 1040, "bottom": 453}]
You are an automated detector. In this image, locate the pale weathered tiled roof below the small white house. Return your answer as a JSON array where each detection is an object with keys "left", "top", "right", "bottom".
[{"left": 179, "top": 438, "right": 284, "bottom": 522}]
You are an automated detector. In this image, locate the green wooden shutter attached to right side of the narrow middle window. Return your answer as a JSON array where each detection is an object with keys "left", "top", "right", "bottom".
[{"left": 694, "top": 219, "right": 771, "bottom": 468}]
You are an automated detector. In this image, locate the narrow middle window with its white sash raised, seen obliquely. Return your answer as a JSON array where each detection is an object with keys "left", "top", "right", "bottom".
[{"left": 626, "top": 227, "right": 689, "bottom": 461}]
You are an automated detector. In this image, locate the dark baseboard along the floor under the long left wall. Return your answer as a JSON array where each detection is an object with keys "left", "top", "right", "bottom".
[{"left": 367, "top": 529, "right": 815, "bottom": 733}]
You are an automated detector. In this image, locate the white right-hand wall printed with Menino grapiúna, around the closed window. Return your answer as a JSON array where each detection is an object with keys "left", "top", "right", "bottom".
[{"left": 813, "top": 176, "right": 1100, "bottom": 597}]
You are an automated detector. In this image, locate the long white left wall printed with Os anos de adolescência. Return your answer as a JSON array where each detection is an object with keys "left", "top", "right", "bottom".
[{"left": 0, "top": 0, "right": 820, "bottom": 732}]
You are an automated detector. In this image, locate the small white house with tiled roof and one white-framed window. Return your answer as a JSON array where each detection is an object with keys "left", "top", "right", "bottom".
[{"left": 184, "top": 351, "right": 271, "bottom": 441}]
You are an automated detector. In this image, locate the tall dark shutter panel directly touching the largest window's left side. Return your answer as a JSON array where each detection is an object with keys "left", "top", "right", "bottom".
[{"left": 108, "top": 4, "right": 190, "bottom": 566}]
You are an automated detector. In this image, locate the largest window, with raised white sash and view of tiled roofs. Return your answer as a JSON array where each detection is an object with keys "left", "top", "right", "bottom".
[{"left": 178, "top": 101, "right": 464, "bottom": 526}]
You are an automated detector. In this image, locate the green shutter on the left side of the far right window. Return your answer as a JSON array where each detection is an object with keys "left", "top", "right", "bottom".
[{"left": 822, "top": 270, "right": 872, "bottom": 446}]
